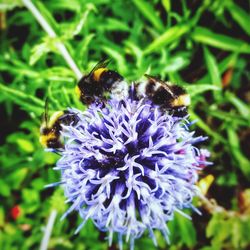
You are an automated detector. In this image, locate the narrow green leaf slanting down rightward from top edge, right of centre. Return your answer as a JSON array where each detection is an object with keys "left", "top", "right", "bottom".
[{"left": 133, "top": 0, "right": 164, "bottom": 31}]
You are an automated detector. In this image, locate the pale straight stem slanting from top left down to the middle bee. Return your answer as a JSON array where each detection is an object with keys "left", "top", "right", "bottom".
[{"left": 22, "top": 0, "right": 82, "bottom": 80}]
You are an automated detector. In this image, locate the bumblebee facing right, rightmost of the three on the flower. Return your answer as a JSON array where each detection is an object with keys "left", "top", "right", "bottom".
[{"left": 135, "top": 74, "right": 191, "bottom": 116}]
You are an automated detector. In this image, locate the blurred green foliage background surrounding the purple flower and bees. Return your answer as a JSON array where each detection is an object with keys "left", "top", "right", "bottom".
[{"left": 0, "top": 0, "right": 250, "bottom": 250}]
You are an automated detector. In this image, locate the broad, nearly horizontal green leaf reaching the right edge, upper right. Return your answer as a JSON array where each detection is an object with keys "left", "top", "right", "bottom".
[{"left": 191, "top": 27, "right": 250, "bottom": 54}]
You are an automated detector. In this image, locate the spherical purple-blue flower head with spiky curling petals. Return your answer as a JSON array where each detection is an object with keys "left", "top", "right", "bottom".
[{"left": 53, "top": 92, "right": 208, "bottom": 249}]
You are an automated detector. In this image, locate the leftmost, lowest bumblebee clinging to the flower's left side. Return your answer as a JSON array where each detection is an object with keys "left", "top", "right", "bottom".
[{"left": 40, "top": 101, "right": 78, "bottom": 149}]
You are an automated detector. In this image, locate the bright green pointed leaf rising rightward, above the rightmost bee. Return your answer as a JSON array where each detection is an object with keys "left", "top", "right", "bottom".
[{"left": 144, "top": 24, "right": 191, "bottom": 54}]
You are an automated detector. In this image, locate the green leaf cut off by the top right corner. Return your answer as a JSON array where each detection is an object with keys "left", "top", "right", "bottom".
[{"left": 225, "top": 1, "right": 250, "bottom": 35}]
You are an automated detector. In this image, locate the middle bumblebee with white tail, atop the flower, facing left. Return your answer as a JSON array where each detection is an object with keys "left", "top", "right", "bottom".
[{"left": 76, "top": 60, "right": 128, "bottom": 105}]
